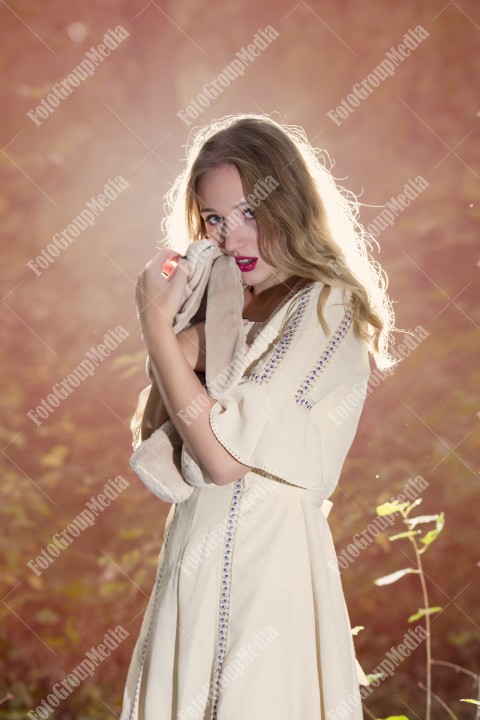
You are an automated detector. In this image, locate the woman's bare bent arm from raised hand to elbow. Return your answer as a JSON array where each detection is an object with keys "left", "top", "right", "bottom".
[{"left": 137, "top": 250, "right": 251, "bottom": 485}]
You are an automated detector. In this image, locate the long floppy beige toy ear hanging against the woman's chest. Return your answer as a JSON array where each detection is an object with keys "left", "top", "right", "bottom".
[{"left": 205, "top": 254, "right": 245, "bottom": 398}]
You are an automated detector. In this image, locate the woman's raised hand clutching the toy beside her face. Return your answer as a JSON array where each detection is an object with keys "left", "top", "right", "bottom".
[{"left": 135, "top": 248, "right": 188, "bottom": 338}]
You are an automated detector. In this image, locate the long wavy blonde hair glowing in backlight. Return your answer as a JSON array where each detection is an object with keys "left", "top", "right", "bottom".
[{"left": 162, "top": 114, "right": 396, "bottom": 370}]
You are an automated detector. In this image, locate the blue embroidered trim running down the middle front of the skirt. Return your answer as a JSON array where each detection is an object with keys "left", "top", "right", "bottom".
[{"left": 210, "top": 477, "right": 245, "bottom": 720}]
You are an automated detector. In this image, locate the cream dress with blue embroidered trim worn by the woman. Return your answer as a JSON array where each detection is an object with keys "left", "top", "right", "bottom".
[{"left": 121, "top": 281, "right": 370, "bottom": 720}]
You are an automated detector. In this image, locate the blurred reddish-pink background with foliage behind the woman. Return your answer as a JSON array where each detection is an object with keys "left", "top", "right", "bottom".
[{"left": 0, "top": 0, "right": 480, "bottom": 720}]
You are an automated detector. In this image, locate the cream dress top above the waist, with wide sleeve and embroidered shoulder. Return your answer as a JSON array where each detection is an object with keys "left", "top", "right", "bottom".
[{"left": 210, "top": 283, "right": 370, "bottom": 497}]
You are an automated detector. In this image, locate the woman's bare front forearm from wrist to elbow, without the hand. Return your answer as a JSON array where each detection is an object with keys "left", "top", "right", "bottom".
[{"left": 144, "top": 316, "right": 250, "bottom": 485}]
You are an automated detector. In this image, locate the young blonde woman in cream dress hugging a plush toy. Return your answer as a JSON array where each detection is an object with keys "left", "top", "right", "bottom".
[{"left": 121, "top": 115, "right": 393, "bottom": 720}]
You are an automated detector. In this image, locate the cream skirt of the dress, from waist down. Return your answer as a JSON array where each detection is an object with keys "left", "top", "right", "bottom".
[{"left": 121, "top": 472, "right": 368, "bottom": 720}]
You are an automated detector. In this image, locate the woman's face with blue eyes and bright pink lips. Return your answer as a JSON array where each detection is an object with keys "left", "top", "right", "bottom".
[{"left": 197, "top": 163, "right": 288, "bottom": 293}]
